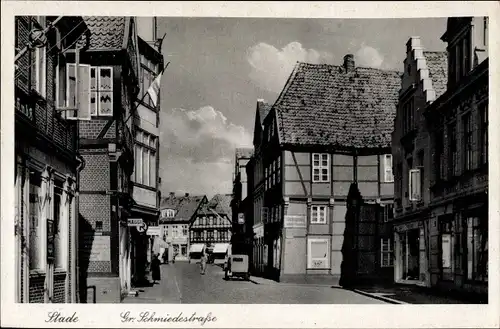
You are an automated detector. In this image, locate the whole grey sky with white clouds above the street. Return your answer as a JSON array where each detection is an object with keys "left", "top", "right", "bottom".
[{"left": 155, "top": 17, "right": 446, "bottom": 197}]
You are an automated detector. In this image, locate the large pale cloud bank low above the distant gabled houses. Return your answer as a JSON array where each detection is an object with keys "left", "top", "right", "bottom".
[{"left": 160, "top": 106, "right": 252, "bottom": 194}]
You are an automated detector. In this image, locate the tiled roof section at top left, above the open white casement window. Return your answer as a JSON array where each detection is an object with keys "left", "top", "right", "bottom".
[{"left": 83, "top": 16, "right": 127, "bottom": 50}]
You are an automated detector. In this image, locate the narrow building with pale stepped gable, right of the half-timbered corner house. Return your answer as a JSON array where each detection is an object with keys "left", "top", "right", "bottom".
[{"left": 392, "top": 37, "right": 448, "bottom": 286}]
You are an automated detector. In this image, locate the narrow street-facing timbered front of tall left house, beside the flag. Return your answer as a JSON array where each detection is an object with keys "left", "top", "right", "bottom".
[{"left": 130, "top": 17, "right": 163, "bottom": 288}]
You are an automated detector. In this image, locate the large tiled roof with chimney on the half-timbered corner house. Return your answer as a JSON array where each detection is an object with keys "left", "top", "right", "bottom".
[{"left": 273, "top": 63, "right": 401, "bottom": 148}]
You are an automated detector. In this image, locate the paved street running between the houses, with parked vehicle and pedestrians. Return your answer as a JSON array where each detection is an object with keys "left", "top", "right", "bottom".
[{"left": 123, "top": 262, "right": 383, "bottom": 304}]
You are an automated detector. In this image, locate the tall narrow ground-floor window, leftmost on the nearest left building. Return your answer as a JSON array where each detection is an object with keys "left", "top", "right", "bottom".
[{"left": 29, "top": 173, "right": 45, "bottom": 270}]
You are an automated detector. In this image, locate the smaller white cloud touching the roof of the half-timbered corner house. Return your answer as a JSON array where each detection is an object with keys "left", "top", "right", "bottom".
[{"left": 247, "top": 41, "right": 333, "bottom": 93}]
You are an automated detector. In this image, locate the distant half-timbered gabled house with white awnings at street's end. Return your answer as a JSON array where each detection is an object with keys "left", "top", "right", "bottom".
[{"left": 189, "top": 194, "right": 232, "bottom": 253}]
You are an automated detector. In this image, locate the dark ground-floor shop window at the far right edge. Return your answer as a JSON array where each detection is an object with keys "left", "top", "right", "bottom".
[{"left": 467, "top": 216, "right": 488, "bottom": 281}]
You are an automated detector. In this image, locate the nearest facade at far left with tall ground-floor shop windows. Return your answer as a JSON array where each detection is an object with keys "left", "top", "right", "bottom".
[{"left": 14, "top": 16, "right": 87, "bottom": 303}]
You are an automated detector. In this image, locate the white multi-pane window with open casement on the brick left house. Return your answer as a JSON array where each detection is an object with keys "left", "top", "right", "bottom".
[{"left": 65, "top": 63, "right": 113, "bottom": 120}]
